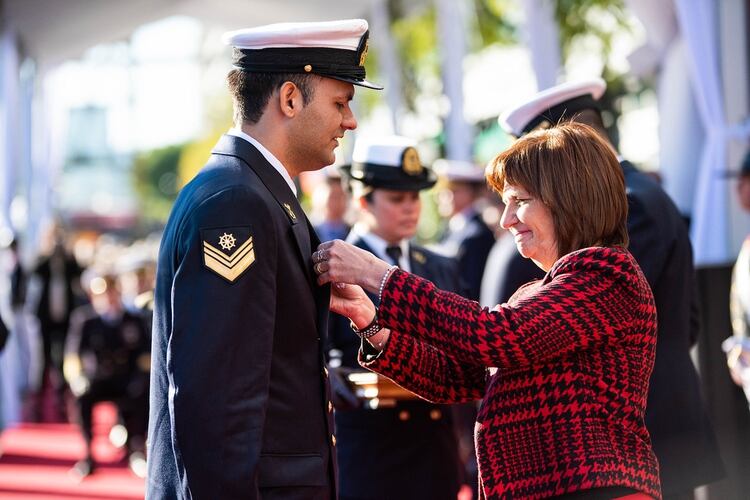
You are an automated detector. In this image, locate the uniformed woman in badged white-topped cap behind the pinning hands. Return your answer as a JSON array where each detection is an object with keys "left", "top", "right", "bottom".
[{"left": 328, "top": 136, "right": 463, "bottom": 500}]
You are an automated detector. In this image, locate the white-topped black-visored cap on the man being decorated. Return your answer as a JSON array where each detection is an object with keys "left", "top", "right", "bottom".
[{"left": 222, "top": 19, "right": 383, "bottom": 90}]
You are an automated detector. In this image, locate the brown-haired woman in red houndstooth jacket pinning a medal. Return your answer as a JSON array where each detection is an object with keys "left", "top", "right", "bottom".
[{"left": 313, "top": 123, "right": 661, "bottom": 499}]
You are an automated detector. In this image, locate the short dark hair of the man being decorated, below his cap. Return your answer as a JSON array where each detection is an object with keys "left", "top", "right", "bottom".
[{"left": 227, "top": 69, "right": 318, "bottom": 123}]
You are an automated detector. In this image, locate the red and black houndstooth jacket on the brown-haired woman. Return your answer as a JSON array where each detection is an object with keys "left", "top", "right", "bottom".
[{"left": 360, "top": 247, "right": 661, "bottom": 499}]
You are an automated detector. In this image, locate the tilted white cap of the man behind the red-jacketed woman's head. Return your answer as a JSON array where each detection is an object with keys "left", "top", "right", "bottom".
[{"left": 497, "top": 78, "right": 607, "bottom": 137}]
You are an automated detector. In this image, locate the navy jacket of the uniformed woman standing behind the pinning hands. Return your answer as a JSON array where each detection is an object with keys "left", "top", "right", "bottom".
[{"left": 329, "top": 239, "right": 463, "bottom": 500}]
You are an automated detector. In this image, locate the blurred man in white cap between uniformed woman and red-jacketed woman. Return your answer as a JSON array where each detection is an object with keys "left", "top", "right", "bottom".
[{"left": 433, "top": 159, "right": 495, "bottom": 300}]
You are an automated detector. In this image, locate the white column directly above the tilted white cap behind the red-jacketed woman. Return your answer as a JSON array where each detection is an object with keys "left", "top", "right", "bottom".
[{"left": 523, "top": 0, "right": 562, "bottom": 90}]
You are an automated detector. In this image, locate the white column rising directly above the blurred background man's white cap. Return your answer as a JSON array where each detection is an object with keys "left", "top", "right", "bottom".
[{"left": 437, "top": 0, "right": 473, "bottom": 161}]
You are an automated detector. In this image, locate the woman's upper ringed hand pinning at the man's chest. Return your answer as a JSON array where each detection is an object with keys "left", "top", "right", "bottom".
[{"left": 312, "top": 240, "right": 391, "bottom": 293}]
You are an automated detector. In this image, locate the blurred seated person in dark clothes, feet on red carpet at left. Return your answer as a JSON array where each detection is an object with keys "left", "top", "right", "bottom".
[{"left": 65, "top": 270, "right": 151, "bottom": 478}]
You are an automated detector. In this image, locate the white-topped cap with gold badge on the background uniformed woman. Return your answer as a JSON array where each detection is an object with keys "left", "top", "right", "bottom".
[{"left": 341, "top": 136, "right": 437, "bottom": 192}]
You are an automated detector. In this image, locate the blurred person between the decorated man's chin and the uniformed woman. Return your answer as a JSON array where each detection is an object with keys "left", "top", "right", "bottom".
[{"left": 312, "top": 165, "right": 351, "bottom": 241}]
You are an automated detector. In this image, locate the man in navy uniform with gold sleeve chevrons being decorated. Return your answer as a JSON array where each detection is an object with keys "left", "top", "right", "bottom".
[{"left": 146, "top": 20, "right": 381, "bottom": 500}]
